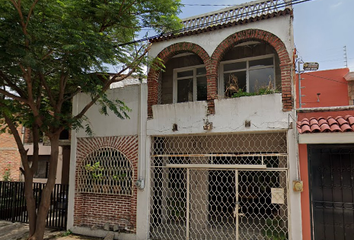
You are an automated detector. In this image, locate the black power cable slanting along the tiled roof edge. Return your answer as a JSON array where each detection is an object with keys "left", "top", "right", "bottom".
[{"left": 118, "top": 0, "right": 313, "bottom": 47}]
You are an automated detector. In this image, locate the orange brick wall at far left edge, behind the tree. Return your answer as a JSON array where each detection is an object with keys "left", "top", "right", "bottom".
[{"left": 0, "top": 127, "right": 22, "bottom": 181}]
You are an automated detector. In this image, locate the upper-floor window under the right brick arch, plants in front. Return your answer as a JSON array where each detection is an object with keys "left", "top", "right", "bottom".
[{"left": 219, "top": 55, "right": 276, "bottom": 97}]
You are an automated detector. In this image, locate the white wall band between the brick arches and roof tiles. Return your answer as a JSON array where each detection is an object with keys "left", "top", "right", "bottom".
[{"left": 149, "top": 15, "right": 294, "bottom": 57}]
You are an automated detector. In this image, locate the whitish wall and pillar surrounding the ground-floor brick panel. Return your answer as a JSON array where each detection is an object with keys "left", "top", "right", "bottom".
[{"left": 67, "top": 84, "right": 150, "bottom": 240}]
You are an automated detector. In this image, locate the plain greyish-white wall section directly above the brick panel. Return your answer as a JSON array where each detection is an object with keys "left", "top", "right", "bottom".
[{"left": 74, "top": 84, "right": 141, "bottom": 137}]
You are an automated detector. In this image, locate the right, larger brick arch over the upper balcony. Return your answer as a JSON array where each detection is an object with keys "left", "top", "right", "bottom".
[{"left": 210, "top": 29, "right": 293, "bottom": 111}]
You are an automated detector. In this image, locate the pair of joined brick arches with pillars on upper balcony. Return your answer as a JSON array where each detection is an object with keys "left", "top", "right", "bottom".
[{"left": 147, "top": 29, "right": 293, "bottom": 117}]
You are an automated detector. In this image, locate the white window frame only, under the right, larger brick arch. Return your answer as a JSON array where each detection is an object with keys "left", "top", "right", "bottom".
[{"left": 218, "top": 54, "right": 276, "bottom": 98}]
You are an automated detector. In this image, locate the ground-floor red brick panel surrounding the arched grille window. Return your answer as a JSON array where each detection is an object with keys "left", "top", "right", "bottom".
[{"left": 74, "top": 136, "right": 138, "bottom": 231}]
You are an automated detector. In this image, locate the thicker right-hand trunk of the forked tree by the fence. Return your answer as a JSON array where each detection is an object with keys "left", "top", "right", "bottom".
[{"left": 28, "top": 134, "right": 59, "bottom": 240}]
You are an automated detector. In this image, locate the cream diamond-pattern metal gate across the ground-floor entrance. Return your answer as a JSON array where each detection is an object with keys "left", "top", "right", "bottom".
[{"left": 150, "top": 133, "right": 288, "bottom": 240}]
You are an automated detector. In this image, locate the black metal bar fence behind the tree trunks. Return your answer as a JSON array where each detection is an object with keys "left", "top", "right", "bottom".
[{"left": 0, "top": 181, "right": 69, "bottom": 229}]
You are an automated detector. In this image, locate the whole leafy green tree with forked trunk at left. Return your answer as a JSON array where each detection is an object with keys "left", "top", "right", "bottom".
[{"left": 0, "top": 0, "right": 180, "bottom": 240}]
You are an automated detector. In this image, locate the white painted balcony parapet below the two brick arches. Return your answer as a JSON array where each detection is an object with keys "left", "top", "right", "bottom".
[{"left": 147, "top": 93, "right": 289, "bottom": 136}]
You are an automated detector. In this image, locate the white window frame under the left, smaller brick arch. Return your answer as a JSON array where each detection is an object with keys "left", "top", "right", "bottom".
[{"left": 173, "top": 64, "right": 207, "bottom": 103}]
